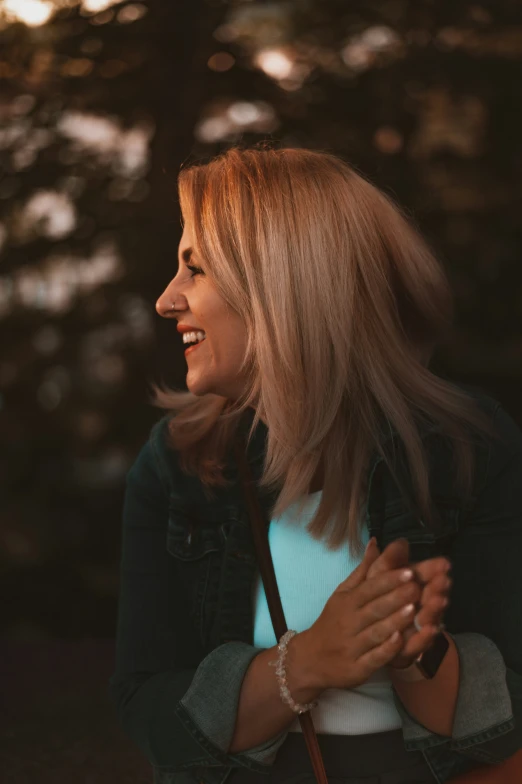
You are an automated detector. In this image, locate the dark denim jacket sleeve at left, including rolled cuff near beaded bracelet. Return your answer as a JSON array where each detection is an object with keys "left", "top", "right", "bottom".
[{"left": 109, "top": 438, "right": 286, "bottom": 774}]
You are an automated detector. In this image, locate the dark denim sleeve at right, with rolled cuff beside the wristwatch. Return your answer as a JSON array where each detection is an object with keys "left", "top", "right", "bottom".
[{"left": 393, "top": 406, "right": 522, "bottom": 763}]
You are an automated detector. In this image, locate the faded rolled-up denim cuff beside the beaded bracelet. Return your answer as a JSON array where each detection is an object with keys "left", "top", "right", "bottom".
[{"left": 180, "top": 641, "right": 288, "bottom": 772}]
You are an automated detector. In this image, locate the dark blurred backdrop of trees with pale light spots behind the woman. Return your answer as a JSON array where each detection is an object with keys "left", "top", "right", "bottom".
[{"left": 0, "top": 0, "right": 522, "bottom": 784}]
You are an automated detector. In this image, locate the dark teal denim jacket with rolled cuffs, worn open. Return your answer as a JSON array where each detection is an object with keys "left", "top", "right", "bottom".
[{"left": 109, "top": 385, "right": 522, "bottom": 784}]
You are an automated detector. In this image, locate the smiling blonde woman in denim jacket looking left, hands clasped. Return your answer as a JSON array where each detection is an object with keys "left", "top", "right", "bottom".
[{"left": 110, "top": 148, "right": 522, "bottom": 784}]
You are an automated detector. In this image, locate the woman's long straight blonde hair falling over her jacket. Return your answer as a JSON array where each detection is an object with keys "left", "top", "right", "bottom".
[{"left": 149, "top": 146, "right": 493, "bottom": 556}]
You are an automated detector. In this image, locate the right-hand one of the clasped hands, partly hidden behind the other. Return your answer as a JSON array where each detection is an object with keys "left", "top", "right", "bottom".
[{"left": 366, "top": 539, "right": 452, "bottom": 669}]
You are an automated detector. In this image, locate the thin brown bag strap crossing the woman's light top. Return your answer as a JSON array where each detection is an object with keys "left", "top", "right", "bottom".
[{"left": 235, "top": 434, "right": 328, "bottom": 784}]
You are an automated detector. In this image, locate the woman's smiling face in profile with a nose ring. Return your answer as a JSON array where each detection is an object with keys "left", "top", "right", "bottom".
[{"left": 156, "top": 222, "right": 247, "bottom": 400}]
